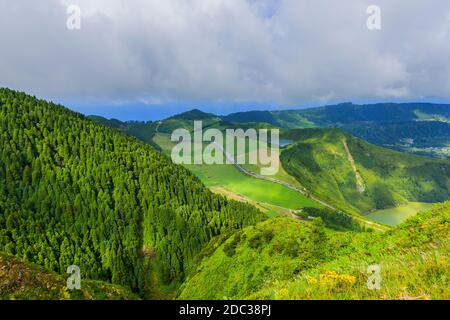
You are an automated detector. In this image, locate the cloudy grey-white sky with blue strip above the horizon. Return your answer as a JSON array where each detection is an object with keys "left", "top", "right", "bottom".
[{"left": 0, "top": 0, "right": 450, "bottom": 120}]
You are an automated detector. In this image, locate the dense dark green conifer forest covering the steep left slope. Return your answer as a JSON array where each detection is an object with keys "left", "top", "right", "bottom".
[{"left": 0, "top": 89, "right": 264, "bottom": 297}]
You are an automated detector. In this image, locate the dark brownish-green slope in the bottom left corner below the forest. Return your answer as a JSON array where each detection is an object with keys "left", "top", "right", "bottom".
[{"left": 0, "top": 253, "right": 139, "bottom": 300}]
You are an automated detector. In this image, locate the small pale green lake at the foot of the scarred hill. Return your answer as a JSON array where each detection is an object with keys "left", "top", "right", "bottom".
[{"left": 366, "top": 202, "right": 432, "bottom": 226}]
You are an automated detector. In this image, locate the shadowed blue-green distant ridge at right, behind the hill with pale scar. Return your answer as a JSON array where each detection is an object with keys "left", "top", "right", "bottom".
[{"left": 223, "top": 103, "right": 450, "bottom": 158}]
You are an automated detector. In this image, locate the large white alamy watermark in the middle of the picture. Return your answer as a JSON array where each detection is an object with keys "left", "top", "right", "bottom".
[{"left": 171, "top": 121, "right": 280, "bottom": 176}]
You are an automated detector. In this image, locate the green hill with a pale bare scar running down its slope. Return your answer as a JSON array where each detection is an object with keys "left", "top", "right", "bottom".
[{"left": 281, "top": 129, "right": 450, "bottom": 213}]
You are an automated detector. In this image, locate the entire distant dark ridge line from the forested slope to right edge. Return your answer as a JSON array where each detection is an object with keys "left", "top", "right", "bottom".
[{"left": 91, "top": 103, "right": 450, "bottom": 158}]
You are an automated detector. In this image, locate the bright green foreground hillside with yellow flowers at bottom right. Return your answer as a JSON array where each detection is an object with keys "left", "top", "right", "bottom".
[{"left": 178, "top": 203, "right": 450, "bottom": 299}]
